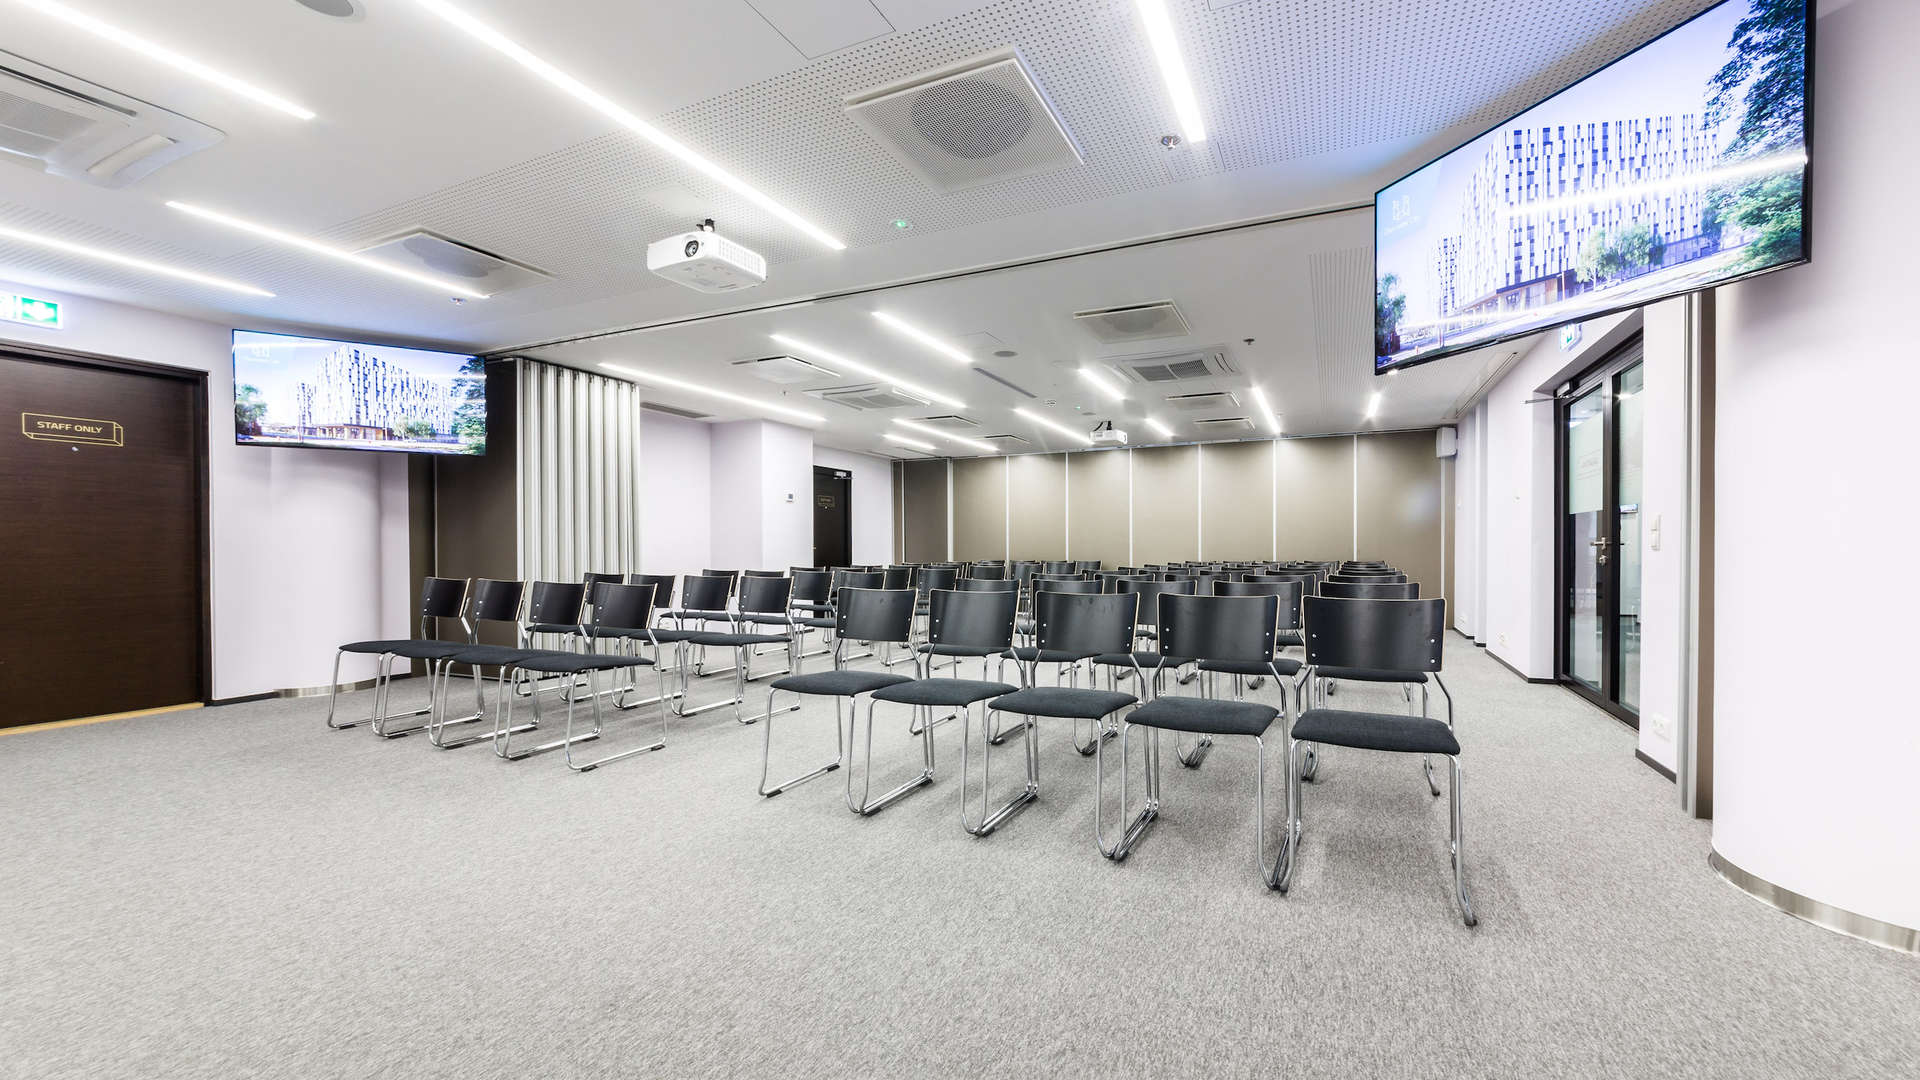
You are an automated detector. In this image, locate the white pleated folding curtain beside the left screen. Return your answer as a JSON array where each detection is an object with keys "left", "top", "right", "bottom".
[{"left": 516, "top": 359, "right": 639, "bottom": 580}]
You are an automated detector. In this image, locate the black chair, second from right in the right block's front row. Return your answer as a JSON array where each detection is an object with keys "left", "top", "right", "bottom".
[{"left": 1094, "top": 594, "right": 1284, "bottom": 864}]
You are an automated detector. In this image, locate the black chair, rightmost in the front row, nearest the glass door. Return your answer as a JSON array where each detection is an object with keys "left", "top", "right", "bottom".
[{"left": 1269, "top": 596, "right": 1475, "bottom": 926}]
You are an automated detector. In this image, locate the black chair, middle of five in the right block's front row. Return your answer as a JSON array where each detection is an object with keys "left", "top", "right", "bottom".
[{"left": 960, "top": 592, "right": 1140, "bottom": 836}]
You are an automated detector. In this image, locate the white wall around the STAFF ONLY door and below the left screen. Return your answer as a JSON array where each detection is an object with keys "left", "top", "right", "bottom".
[{"left": 0, "top": 282, "right": 408, "bottom": 698}]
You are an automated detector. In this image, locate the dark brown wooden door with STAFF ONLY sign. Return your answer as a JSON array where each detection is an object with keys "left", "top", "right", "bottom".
[{"left": 0, "top": 352, "right": 207, "bottom": 726}]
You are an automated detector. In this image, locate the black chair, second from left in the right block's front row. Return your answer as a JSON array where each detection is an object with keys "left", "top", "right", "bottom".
[{"left": 847, "top": 580, "right": 1020, "bottom": 815}]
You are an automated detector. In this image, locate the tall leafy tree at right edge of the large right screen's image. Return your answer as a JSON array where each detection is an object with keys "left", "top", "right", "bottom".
[{"left": 1707, "top": 0, "right": 1807, "bottom": 269}]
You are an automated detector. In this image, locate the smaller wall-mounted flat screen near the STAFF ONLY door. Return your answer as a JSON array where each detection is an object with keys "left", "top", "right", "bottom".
[{"left": 234, "top": 322, "right": 486, "bottom": 454}]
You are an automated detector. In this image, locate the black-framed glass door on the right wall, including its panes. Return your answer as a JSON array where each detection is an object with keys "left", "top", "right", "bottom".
[{"left": 1557, "top": 338, "right": 1645, "bottom": 726}]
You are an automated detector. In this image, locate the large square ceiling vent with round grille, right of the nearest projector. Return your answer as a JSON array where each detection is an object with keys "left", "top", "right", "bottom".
[{"left": 845, "top": 48, "right": 1085, "bottom": 192}]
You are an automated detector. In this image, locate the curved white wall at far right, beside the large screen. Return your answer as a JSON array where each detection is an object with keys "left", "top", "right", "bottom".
[{"left": 1713, "top": 0, "right": 1920, "bottom": 928}]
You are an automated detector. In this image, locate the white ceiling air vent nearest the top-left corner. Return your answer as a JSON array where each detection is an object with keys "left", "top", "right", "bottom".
[{"left": 0, "top": 52, "right": 227, "bottom": 188}]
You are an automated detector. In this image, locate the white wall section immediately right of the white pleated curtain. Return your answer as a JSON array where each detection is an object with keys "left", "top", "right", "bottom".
[{"left": 639, "top": 411, "right": 714, "bottom": 575}]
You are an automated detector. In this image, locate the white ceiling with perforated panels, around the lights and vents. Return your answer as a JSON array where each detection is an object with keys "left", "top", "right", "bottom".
[{"left": 0, "top": 0, "right": 1711, "bottom": 450}]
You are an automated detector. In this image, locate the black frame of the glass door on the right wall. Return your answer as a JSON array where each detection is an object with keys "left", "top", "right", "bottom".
[{"left": 1553, "top": 331, "right": 1645, "bottom": 730}]
